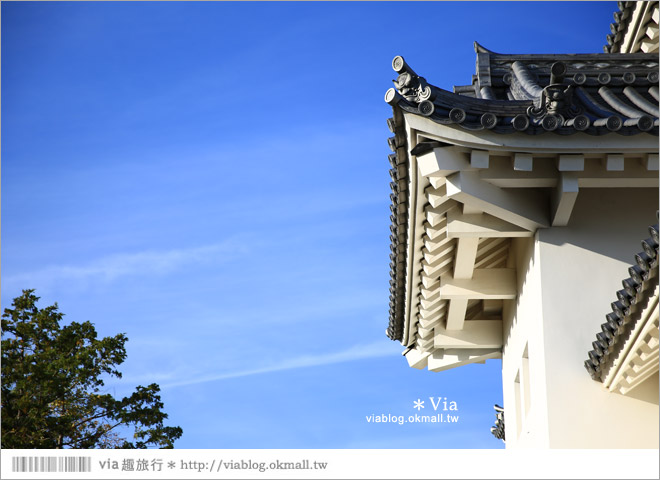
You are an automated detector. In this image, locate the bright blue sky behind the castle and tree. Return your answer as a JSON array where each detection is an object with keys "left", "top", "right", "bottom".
[{"left": 2, "top": 2, "right": 617, "bottom": 448}]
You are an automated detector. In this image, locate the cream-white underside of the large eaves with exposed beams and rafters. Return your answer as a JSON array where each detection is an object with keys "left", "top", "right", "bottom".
[{"left": 392, "top": 116, "right": 658, "bottom": 371}]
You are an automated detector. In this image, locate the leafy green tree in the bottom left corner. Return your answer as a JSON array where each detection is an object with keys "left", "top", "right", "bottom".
[{"left": 0, "top": 290, "right": 182, "bottom": 448}]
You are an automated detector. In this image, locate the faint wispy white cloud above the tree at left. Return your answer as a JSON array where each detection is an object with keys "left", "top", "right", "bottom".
[{"left": 3, "top": 241, "right": 245, "bottom": 287}]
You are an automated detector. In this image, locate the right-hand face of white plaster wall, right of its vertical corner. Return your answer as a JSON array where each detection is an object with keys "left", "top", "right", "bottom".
[{"left": 530, "top": 189, "right": 658, "bottom": 448}]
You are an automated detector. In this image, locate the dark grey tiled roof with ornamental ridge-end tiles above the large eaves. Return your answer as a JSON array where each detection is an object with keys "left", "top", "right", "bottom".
[{"left": 386, "top": 47, "right": 658, "bottom": 135}]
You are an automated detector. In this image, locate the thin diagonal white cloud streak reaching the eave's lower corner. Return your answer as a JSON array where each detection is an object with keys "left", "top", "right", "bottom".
[{"left": 161, "top": 340, "right": 396, "bottom": 388}]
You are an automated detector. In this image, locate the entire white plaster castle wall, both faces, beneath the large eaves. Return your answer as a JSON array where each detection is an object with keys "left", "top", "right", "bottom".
[{"left": 502, "top": 189, "right": 659, "bottom": 448}]
